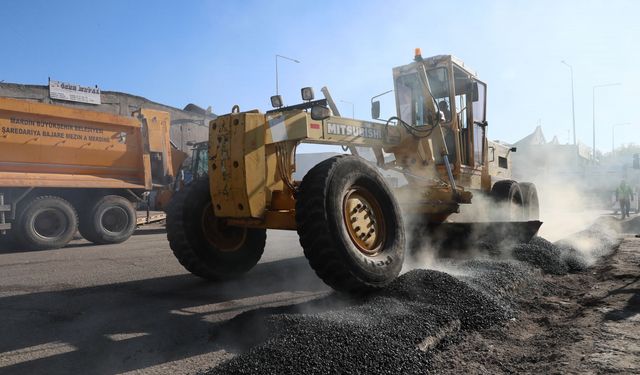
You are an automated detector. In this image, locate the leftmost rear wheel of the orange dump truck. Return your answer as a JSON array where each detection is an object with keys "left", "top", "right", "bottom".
[{"left": 12, "top": 196, "right": 78, "bottom": 250}]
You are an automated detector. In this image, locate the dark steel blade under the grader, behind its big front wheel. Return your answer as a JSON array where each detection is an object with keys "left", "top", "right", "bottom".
[{"left": 426, "top": 220, "right": 542, "bottom": 252}]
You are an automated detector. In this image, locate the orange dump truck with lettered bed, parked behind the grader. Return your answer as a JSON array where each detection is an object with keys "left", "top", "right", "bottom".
[{"left": 0, "top": 98, "right": 185, "bottom": 249}]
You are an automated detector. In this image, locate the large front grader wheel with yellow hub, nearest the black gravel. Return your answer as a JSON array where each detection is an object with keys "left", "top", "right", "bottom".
[{"left": 296, "top": 155, "right": 405, "bottom": 293}]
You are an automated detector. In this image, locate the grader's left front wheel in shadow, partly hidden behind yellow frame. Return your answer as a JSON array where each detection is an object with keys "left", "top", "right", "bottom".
[{"left": 167, "top": 179, "right": 267, "bottom": 280}]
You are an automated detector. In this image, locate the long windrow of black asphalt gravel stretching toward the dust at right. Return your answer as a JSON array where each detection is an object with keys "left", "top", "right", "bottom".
[{"left": 206, "top": 220, "right": 618, "bottom": 374}]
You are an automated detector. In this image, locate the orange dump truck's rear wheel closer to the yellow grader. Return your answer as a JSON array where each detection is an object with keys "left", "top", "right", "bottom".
[{"left": 78, "top": 195, "right": 136, "bottom": 245}]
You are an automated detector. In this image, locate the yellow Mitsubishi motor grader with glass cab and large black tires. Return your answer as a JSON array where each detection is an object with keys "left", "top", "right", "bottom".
[{"left": 167, "top": 50, "right": 541, "bottom": 293}]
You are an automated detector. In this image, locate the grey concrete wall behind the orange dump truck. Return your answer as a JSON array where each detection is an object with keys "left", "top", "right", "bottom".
[{"left": 0, "top": 83, "right": 216, "bottom": 154}]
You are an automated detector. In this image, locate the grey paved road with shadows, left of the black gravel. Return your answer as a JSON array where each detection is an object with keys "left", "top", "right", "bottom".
[{"left": 0, "top": 227, "right": 328, "bottom": 374}]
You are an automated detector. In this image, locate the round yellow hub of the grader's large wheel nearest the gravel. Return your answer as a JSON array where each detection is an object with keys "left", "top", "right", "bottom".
[{"left": 343, "top": 187, "right": 385, "bottom": 256}]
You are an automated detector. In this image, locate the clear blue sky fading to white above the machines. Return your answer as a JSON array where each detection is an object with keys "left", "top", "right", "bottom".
[{"left": 0, "top": 0, "right": 640, "bottom": 152}]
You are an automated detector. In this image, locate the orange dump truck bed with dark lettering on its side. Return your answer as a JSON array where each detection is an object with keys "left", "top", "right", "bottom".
[{"left": 0, "top": 98, "right": 151, "bottom": 189}]
